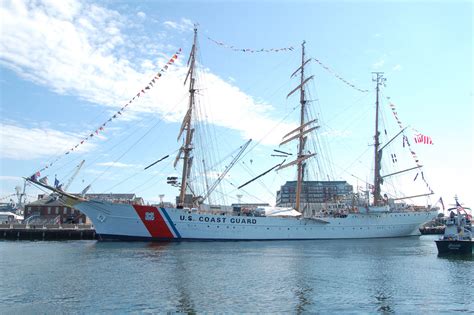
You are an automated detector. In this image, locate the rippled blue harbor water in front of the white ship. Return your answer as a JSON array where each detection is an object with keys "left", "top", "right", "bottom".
[{"left": 0, "top": 235, "right": 474, "bottom": 314}]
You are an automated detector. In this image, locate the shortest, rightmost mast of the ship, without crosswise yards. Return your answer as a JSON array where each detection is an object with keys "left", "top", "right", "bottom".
[{"left": 372, "top": 72, "right": 386, "bottom": 206}]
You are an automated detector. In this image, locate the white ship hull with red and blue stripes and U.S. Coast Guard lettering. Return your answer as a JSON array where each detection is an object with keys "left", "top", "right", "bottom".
[{"left": 74, "top": 201, "right": 437, "bottom": 241}]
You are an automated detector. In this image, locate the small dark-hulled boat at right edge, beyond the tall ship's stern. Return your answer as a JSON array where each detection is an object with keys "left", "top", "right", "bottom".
[{"left": 435, "top": 199, "right": 473, "bottom": 255}]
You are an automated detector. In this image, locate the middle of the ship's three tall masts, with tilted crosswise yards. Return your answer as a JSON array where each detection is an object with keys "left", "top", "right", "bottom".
[{"left": 277, "top": 41, "right": 318, "bottom": 212}]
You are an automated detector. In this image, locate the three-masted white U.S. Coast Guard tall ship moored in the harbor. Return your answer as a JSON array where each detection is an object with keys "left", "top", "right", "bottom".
[{"left": 30, "top": 28, "right": 438, "bottom": 241}]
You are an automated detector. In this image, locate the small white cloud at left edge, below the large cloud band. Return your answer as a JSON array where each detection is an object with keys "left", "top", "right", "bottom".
[{"left": 0, "top": 122, "right": 94, "bottom": 160}]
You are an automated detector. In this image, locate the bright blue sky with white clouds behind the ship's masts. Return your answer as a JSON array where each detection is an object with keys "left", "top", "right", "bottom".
[{"left": 0, "top": 0, "right": 474, "bottom": 210}]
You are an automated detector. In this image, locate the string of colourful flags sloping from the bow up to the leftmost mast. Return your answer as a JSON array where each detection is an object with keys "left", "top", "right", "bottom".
[{"left": 31, "top": 48, "right": 181, "bottom": 180}]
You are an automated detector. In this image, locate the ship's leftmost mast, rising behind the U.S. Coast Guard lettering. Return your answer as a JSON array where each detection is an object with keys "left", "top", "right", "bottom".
[{"left": 176, "top": 25, "right": 197, "bottom": 207}]
